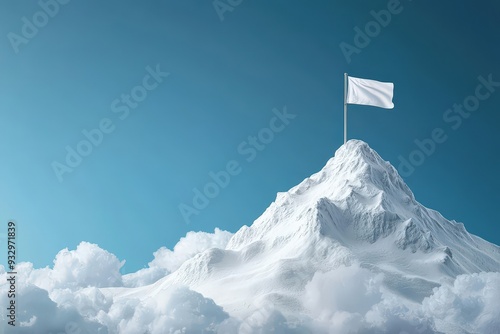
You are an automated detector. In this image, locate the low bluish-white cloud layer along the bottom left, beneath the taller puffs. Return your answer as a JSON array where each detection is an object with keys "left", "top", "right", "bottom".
[{"left": 0, "top": 284, "right": 230, "bottom": 334}]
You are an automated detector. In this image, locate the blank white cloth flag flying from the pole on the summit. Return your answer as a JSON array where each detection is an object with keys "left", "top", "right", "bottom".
[{"left": 346, "top": 77, "right": 394, "bottom": 109}]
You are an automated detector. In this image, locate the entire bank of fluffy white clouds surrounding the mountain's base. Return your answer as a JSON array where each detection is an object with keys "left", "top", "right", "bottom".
[{"left": 0, "top": 229, "right": 500, "bottom": 334}]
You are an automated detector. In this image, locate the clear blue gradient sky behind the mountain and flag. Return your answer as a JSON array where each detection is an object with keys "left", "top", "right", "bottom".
[{"left": 0, "top": 0, "right": 500, "bottom": 273}]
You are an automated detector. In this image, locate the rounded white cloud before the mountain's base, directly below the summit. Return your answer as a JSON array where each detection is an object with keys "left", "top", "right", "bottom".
[{"left": 303, "top": 263, "right": 435, "bottom": 334}]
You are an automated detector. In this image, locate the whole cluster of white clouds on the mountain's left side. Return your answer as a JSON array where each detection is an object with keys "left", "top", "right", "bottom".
[{"left": 0, "top": 229, "right": 239, "bottom": 334}]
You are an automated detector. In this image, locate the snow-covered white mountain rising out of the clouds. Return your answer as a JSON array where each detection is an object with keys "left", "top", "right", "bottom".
[{"left": 105, "top": 140, "right": 500, "bottom": 332}]
